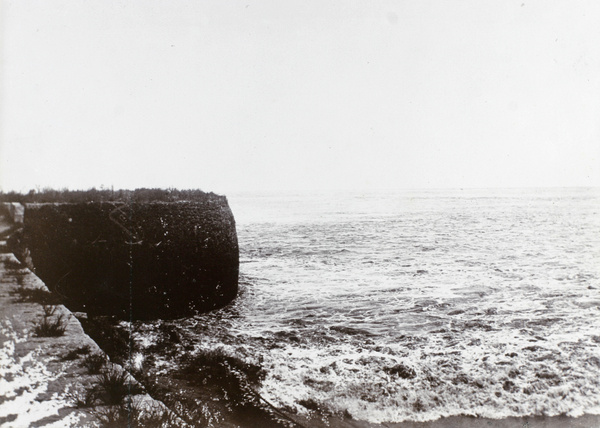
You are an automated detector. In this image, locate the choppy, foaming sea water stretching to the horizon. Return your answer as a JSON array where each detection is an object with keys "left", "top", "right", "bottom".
[{"left": 138, "top": 189, "right": 600, "bottom": 422}]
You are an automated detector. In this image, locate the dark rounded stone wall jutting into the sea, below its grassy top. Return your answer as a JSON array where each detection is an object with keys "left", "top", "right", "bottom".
[{"left": 18, "top": 199, "right": 239, "bottom": 319}]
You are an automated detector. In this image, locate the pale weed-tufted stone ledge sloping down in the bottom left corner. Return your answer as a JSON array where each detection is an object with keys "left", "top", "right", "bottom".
[{"left": 0, "top": 253, "right": 185, "bottom": 428}]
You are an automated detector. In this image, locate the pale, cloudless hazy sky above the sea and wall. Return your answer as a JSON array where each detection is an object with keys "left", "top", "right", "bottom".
[{"left": 0, "top": 0, "right": 600, "bottom": 192}]
